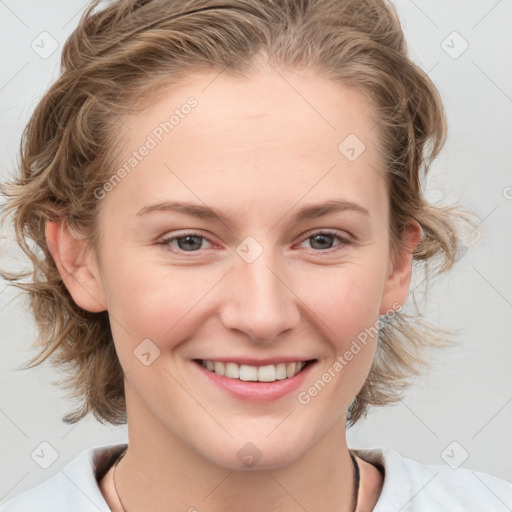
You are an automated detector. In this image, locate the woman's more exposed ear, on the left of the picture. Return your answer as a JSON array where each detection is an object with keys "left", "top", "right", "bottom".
[{"left": 45, "top": 221, "right": 107, "bottom": 313}]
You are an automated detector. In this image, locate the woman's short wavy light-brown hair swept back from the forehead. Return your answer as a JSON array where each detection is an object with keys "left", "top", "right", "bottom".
[{"left": 2, "top": 0, "right": 476, "bottom": 426}]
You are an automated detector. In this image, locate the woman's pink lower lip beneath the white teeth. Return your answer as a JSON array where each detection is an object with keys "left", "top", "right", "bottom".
[{"left": 193, "top": 361, "right": 315, "bottom": 402}]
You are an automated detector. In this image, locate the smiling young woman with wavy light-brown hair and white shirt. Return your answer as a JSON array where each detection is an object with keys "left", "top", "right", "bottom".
[{"left": 0, "top": 0, "right": 512, "bottom": 512}]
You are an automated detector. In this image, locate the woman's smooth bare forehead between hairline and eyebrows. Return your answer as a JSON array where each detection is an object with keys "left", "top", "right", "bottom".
[{"left": 104, "top": 69, "right": 383, "bottom": 224}]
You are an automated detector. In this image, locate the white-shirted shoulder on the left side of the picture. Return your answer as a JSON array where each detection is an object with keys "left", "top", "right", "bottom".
[{"left": 0, "top": 444, "right": 126, "bottom": 512}]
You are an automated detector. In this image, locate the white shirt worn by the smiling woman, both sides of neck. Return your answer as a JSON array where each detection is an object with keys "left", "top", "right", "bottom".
[{"left": 0, "top": 444, "right": 512, "bottom": 512}]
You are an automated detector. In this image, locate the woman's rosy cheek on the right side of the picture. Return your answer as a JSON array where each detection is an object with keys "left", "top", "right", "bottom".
[{"left": 290, "top": 261, "right": 383, "bottom": 414}]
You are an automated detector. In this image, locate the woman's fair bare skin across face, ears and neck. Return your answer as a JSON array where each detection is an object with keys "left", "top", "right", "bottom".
[{"left": 47, "top": 69, "right": 420, "bottom": 512}]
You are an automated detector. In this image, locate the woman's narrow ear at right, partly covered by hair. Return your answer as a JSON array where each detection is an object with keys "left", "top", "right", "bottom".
[{"left": 379, "top": 219, "right": 422, "bottom": 315}]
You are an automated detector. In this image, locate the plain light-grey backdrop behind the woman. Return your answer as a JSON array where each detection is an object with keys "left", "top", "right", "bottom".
[{"left": 0, "top": 0, "right": 512, "bottom": 501}]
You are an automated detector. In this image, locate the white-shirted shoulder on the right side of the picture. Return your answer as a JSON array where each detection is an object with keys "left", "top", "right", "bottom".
[{"left": 353, "top": 448, "right": 512, "bottom": 512}]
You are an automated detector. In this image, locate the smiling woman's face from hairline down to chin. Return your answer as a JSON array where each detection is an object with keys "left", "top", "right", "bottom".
[{"left": 66, "top": 71, "right": 410, "bottom": 469}]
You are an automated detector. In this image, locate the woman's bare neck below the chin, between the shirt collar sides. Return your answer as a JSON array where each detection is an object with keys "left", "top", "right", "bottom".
[{"left": 116, "top": 388, "right": 354, "bottom": 512}]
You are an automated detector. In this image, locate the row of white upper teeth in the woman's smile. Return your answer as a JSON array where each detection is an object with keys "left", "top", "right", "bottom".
[{"left": 201, "top": 360, "right": 306, "bottom": 382}]
